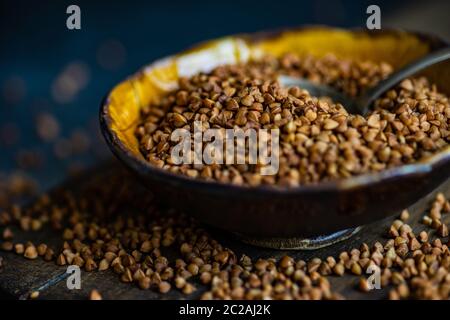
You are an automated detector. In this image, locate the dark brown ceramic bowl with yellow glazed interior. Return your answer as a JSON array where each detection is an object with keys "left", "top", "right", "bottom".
[{"left": 100, "top": 27, "right": 450, "bottom": 245}]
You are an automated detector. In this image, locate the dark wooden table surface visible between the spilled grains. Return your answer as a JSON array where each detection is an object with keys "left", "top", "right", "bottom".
[{"left": 0, "top": 162, "right": 450, "bottom": 299}]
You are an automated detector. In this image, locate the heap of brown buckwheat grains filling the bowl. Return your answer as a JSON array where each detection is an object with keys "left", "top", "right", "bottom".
[{"left": 136, "top": 54, "right": 450, "bottom": 186}]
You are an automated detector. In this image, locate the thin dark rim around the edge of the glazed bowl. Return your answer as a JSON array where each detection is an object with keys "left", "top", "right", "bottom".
[{"left": 99, "top": 25, "right": 450, "bottom": 196}]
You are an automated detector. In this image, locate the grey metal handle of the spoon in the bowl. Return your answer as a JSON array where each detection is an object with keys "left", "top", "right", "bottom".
[{"left": 358, "top": 47, "right": 450, "bottom": 111}]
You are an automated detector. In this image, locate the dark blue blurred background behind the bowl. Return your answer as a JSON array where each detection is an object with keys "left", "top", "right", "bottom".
[{"left": 0, "top": 0, "right": 450, "bottom": 192}]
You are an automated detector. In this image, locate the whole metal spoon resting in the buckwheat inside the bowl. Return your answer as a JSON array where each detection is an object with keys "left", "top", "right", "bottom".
[{"left": 279, "top": 47, "right": 450, "bottom": 115}]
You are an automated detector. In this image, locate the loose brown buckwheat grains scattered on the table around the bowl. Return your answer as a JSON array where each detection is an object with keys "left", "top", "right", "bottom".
[{"left": 0, "top": 170, "right": 450, "bottom": 299}]
